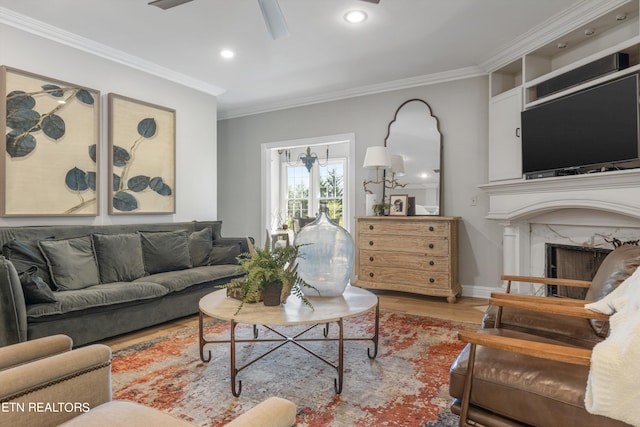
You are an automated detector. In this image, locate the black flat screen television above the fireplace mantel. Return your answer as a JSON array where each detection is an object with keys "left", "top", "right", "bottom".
[{"left": 521, "top": 74, "right": 640, "bottom": 177}]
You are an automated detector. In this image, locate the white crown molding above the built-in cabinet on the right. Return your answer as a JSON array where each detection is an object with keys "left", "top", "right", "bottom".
[{"left": 479, "top": 0, "right": 637, "bottom": 72}]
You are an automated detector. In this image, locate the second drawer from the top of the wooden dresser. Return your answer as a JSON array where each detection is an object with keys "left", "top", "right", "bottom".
[{"left": 358, "top": 235, "right": 449, "bottom": 255}]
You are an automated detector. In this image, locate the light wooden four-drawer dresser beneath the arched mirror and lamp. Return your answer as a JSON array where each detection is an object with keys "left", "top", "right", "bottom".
[{"left": 354, "top": 216, "right": 462, "bottom": 303}]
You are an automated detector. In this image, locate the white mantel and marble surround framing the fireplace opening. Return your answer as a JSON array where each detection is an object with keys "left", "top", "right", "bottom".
[{"left": 479, "top": 169, "right": 640, "bottom": 294}]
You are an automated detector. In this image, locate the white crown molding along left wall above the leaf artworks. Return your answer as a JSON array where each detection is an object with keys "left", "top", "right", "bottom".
[{"left": 0, "top": 7, "right": 225, "bottom": 96}]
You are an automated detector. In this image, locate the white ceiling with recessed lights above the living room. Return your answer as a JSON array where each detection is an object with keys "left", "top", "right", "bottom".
[{"left": 0, "top": 0, "right": 592, "bottom": 118}]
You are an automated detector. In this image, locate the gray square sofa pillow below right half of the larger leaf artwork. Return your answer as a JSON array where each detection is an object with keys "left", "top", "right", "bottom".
[{"left": 38, "top": 236, "right": 100, "bottom": 291}]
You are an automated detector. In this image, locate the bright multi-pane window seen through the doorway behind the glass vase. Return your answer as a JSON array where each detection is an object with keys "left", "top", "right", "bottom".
[{"left": 281, "top": 159, "right": 346, "bottom": 227}]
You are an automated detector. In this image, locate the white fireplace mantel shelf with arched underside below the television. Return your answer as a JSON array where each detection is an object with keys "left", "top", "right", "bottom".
[{"left": 479, "top": 169, "right": 640, "bottom": 221}]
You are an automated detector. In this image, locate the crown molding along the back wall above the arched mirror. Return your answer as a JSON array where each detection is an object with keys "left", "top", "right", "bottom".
[{"left": 218, "top": 66, "right": 487, "bottom": 120}]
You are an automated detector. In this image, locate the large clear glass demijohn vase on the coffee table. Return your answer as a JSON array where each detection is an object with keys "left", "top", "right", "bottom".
[{"left": 295, "top": 203, "right": 354, "bottom": 297}]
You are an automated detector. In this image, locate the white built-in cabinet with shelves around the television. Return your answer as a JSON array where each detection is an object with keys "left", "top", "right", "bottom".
[{"left": 489, "top": 0, "right": 640, "bottom": 182}]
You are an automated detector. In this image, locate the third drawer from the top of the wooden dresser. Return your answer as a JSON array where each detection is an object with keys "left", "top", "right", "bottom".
[{"left": 359, "top": 250, "right": 449, "bottom": 272}]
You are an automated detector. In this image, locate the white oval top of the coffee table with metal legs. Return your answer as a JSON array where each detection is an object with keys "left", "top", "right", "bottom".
[{"left": 199, "top": 285, "right": 378, "bottom": 326}]
